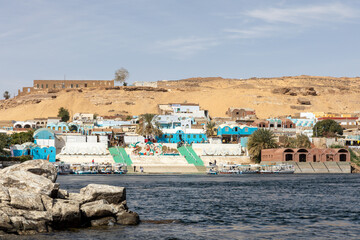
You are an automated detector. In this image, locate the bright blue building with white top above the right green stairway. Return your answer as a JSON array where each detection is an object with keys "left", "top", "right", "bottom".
[{"left": 156, "top": 127, "right": 207, "bottom": 144}]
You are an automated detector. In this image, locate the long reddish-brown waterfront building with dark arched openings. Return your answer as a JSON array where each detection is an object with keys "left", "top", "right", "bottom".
[{"left": 261, "top": 148, "right": 350, "bottom": 162}]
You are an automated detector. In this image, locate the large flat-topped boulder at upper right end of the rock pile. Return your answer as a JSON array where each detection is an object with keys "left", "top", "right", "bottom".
[{"left": 80, "top": 184, "right": 126, "bottom": 204}]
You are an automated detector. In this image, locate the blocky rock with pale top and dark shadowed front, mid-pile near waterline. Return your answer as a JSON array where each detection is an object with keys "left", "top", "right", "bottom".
[{"left": 51, "top": 199, "right": 81, "bottom": 229}]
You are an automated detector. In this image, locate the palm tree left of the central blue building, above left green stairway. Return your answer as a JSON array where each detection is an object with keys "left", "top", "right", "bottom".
[{"left": 136, "top": 113, "right": 163, "bottom": 138}]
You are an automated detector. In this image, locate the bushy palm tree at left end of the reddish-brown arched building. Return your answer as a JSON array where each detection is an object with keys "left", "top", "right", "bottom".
[{"left": 247, "top": 129, "right": 278, "bottom": 163}]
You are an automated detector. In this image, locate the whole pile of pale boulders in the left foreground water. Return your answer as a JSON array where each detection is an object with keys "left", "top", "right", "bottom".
[{"left": 0, "top": 160, "right": 140, "bottom": 234}]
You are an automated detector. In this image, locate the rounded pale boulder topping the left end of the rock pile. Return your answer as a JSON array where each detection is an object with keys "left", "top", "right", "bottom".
[{"left": 0, "top": 160, "right": 57, "bottom": 183}]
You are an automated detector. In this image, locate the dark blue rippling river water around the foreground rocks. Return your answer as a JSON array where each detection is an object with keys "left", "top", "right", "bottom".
[{"left": 7, "top": 174, "right": 360, "bottom": 239}]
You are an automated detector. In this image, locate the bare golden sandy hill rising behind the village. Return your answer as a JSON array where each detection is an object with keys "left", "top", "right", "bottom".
[{"left": 0, "top": 76, "right": 360, "bottom": 120}]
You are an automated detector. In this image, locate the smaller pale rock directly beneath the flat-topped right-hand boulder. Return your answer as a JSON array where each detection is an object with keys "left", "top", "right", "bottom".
[{"left": 81, "top": 199, "right": 116, "bottom": 218}]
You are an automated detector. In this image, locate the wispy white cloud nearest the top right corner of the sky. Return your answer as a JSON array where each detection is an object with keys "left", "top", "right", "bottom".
[{"left": 244, "top": 3, "right": 358, "bottom": 25}]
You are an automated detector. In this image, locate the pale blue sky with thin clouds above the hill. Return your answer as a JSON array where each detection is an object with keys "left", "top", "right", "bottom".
[{"left": 0, "top": 0, "right": 360, "bottom": 97}]
